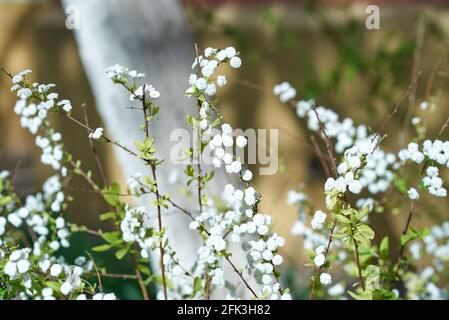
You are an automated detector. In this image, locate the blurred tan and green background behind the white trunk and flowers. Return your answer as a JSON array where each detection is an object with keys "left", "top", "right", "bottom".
[{"left": 0, "top": 0, "right": 449, "bottom": 297}]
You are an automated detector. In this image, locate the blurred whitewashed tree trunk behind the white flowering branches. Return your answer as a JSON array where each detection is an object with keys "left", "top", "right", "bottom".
[{"left": 62, "top": 0, "right": 247, "bottom": 298}]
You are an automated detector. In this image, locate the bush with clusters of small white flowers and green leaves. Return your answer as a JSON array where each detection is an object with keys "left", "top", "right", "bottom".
[{"left": 0, "top": 47, "right": 449, "bottom": 300}]
